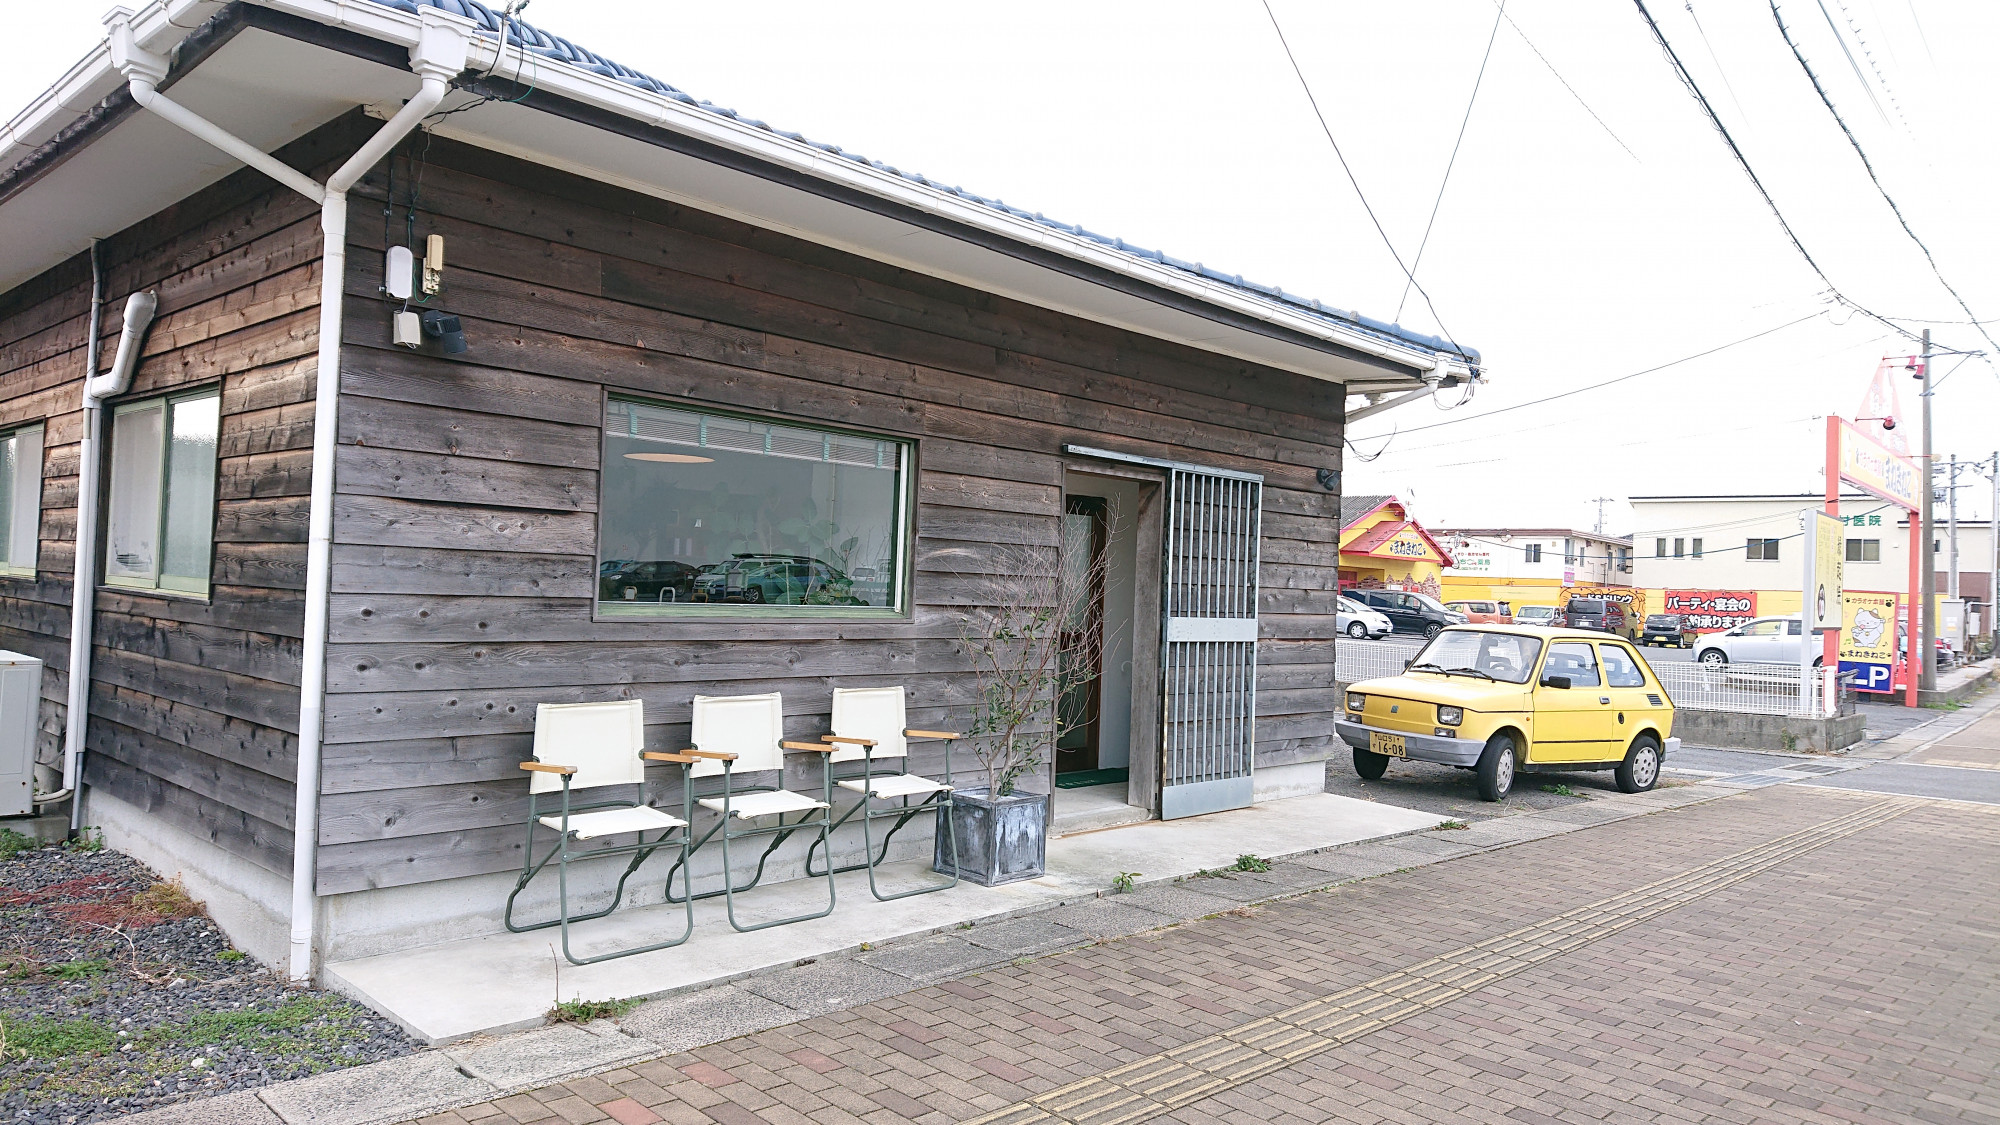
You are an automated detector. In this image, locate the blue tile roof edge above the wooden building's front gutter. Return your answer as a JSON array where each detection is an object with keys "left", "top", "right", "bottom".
[{"left": 374, "top": 0, "right": 1480, "bottom": 364}]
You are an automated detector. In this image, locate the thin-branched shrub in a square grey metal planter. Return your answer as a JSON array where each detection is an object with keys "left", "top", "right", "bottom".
[{"left": 932, "top": 510, "right": 1106, "bottom": 887}]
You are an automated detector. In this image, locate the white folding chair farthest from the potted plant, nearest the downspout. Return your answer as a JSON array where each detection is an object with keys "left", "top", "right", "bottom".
[{"left": 504, "top": 699, "right": 698, "bottom": 965}]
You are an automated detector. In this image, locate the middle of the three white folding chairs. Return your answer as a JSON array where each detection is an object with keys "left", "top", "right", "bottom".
[{"left": 666, "top": 693, "right": 834, "bottom": 933}]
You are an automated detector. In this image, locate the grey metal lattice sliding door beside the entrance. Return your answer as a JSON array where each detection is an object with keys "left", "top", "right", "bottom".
[{"left": 1160, "top": 466, "right": 1264, "bottom": 821}]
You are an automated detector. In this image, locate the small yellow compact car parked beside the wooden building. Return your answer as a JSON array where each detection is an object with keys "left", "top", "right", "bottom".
[{"left": 1334, "top": 625, "right": 1680, "bottom": 801}]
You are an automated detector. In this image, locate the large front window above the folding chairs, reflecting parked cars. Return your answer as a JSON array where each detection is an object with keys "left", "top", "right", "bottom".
[{"left": 598, "top": 398, "right": 912, "bottom": 615}]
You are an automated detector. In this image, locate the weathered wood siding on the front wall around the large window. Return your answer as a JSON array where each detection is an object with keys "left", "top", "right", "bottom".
[{"left": 320, "top": 140, "right": 1342, "bottom": 893}]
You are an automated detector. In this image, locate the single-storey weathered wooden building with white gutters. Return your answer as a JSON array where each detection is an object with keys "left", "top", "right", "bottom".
[{"left": 0, "top": 0, "right": 1478, "bottom": 971}]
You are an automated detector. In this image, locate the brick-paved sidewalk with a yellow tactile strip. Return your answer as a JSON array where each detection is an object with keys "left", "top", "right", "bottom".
[{"left": 406, "top": 787, "right": 2000, "bottom": 1125}]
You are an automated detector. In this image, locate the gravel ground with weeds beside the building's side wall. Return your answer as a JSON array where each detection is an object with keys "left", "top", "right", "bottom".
[{"left": 0, "top": 833, "right": 418, "bottom": 1125}]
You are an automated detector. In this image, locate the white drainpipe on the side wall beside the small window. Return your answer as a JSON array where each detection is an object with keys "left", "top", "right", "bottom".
[{"left": 62, "top": 242, "right": 160, "bottom": 831}]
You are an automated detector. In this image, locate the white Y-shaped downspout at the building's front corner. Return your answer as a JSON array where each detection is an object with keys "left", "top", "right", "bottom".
[{"left": 105, "top": 8, "right": 472, "bottom": 983}]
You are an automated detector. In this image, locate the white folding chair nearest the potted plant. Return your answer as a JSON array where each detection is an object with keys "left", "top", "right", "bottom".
[{"left": 806, "top": 687, "right": 958, "bottom": 903}]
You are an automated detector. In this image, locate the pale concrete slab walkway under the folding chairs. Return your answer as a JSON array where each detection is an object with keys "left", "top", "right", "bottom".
[{"left": 324, "top": 793, "right": 1442, "bottom": 1043}]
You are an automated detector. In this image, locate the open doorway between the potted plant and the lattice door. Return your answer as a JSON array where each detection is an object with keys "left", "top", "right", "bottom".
[{"left": 1052, "top": 470, "right": 1160, "bottom": 833}]
